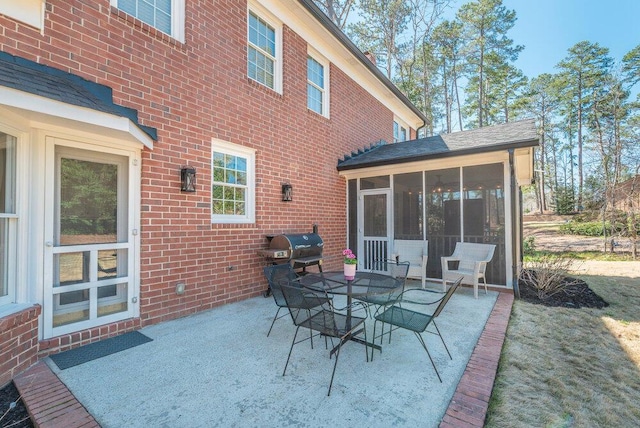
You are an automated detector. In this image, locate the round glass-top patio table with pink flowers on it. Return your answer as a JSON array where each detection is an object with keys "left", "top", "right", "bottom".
[{"left": 298, "top": 271, "right": 403, "bottom": 354}]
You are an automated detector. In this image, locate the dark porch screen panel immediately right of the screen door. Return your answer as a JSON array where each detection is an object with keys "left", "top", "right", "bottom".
[{"left": 393, "top": 172, "right": 423, "bottom": 240}]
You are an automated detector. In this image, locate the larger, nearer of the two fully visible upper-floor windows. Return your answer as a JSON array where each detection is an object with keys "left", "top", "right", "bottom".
[{"left": 247, "top": 10, "right": 282, "bottom": 92}]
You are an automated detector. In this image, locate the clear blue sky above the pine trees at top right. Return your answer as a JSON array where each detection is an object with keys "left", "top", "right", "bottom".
[{"left": 476, "top": 0, "right": 640, "bottom": 78}]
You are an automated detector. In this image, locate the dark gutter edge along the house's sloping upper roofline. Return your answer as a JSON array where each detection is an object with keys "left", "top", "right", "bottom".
[{"left": 298, "top": 0, "right": 427, "bottom": 126}]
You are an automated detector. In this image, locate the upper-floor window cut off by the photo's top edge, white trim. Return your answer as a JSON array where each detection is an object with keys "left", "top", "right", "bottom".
[{"left": 111, "top": 0, "right": 185, "bottom": 42}]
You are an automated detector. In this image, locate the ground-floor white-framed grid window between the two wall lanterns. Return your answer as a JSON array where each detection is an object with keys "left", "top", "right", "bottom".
[{"left": 211, "top": 140, "right": 255, "bottom": 223}]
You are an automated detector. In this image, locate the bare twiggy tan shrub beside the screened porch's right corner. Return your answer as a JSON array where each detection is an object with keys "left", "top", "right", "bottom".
[{"left": 520, "top": 253, "right": 579, "bottom": 300}]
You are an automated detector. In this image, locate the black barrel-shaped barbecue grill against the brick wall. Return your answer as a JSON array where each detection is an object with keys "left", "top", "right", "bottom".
[{"left": 258, "top": 226, "right": 324, "bottom": 295}]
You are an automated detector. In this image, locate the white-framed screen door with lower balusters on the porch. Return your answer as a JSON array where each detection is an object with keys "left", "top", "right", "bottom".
[{"left": 358, "top": 190, "right": 392, "bottom": 270}]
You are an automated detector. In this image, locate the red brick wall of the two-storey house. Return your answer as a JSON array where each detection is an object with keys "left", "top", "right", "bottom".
[{"left": 0, "top": 0, "right": 400, "bottom": 354}]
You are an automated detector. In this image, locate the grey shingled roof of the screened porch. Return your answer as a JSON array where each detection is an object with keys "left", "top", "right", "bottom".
[{"left": 338, "top": 119, "right": 539, "bottom": 171}]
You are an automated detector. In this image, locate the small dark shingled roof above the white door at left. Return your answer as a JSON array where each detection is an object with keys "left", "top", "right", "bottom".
[{"left": 0, "top": 52, "right": 158, "bottom": 145}]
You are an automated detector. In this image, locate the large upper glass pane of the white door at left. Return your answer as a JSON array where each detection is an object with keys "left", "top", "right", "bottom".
[{"left": 60, "top": 158, "right": 118, "bottom": 245}]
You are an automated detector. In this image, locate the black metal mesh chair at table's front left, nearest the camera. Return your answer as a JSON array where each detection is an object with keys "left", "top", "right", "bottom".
[{"left": 281, "top": 281, "right": 369, "bottom": 395}]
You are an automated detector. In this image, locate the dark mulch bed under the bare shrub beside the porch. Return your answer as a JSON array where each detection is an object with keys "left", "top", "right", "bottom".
[{"left": 519, "top": 277, "right": 609, "bottom": 309}]
